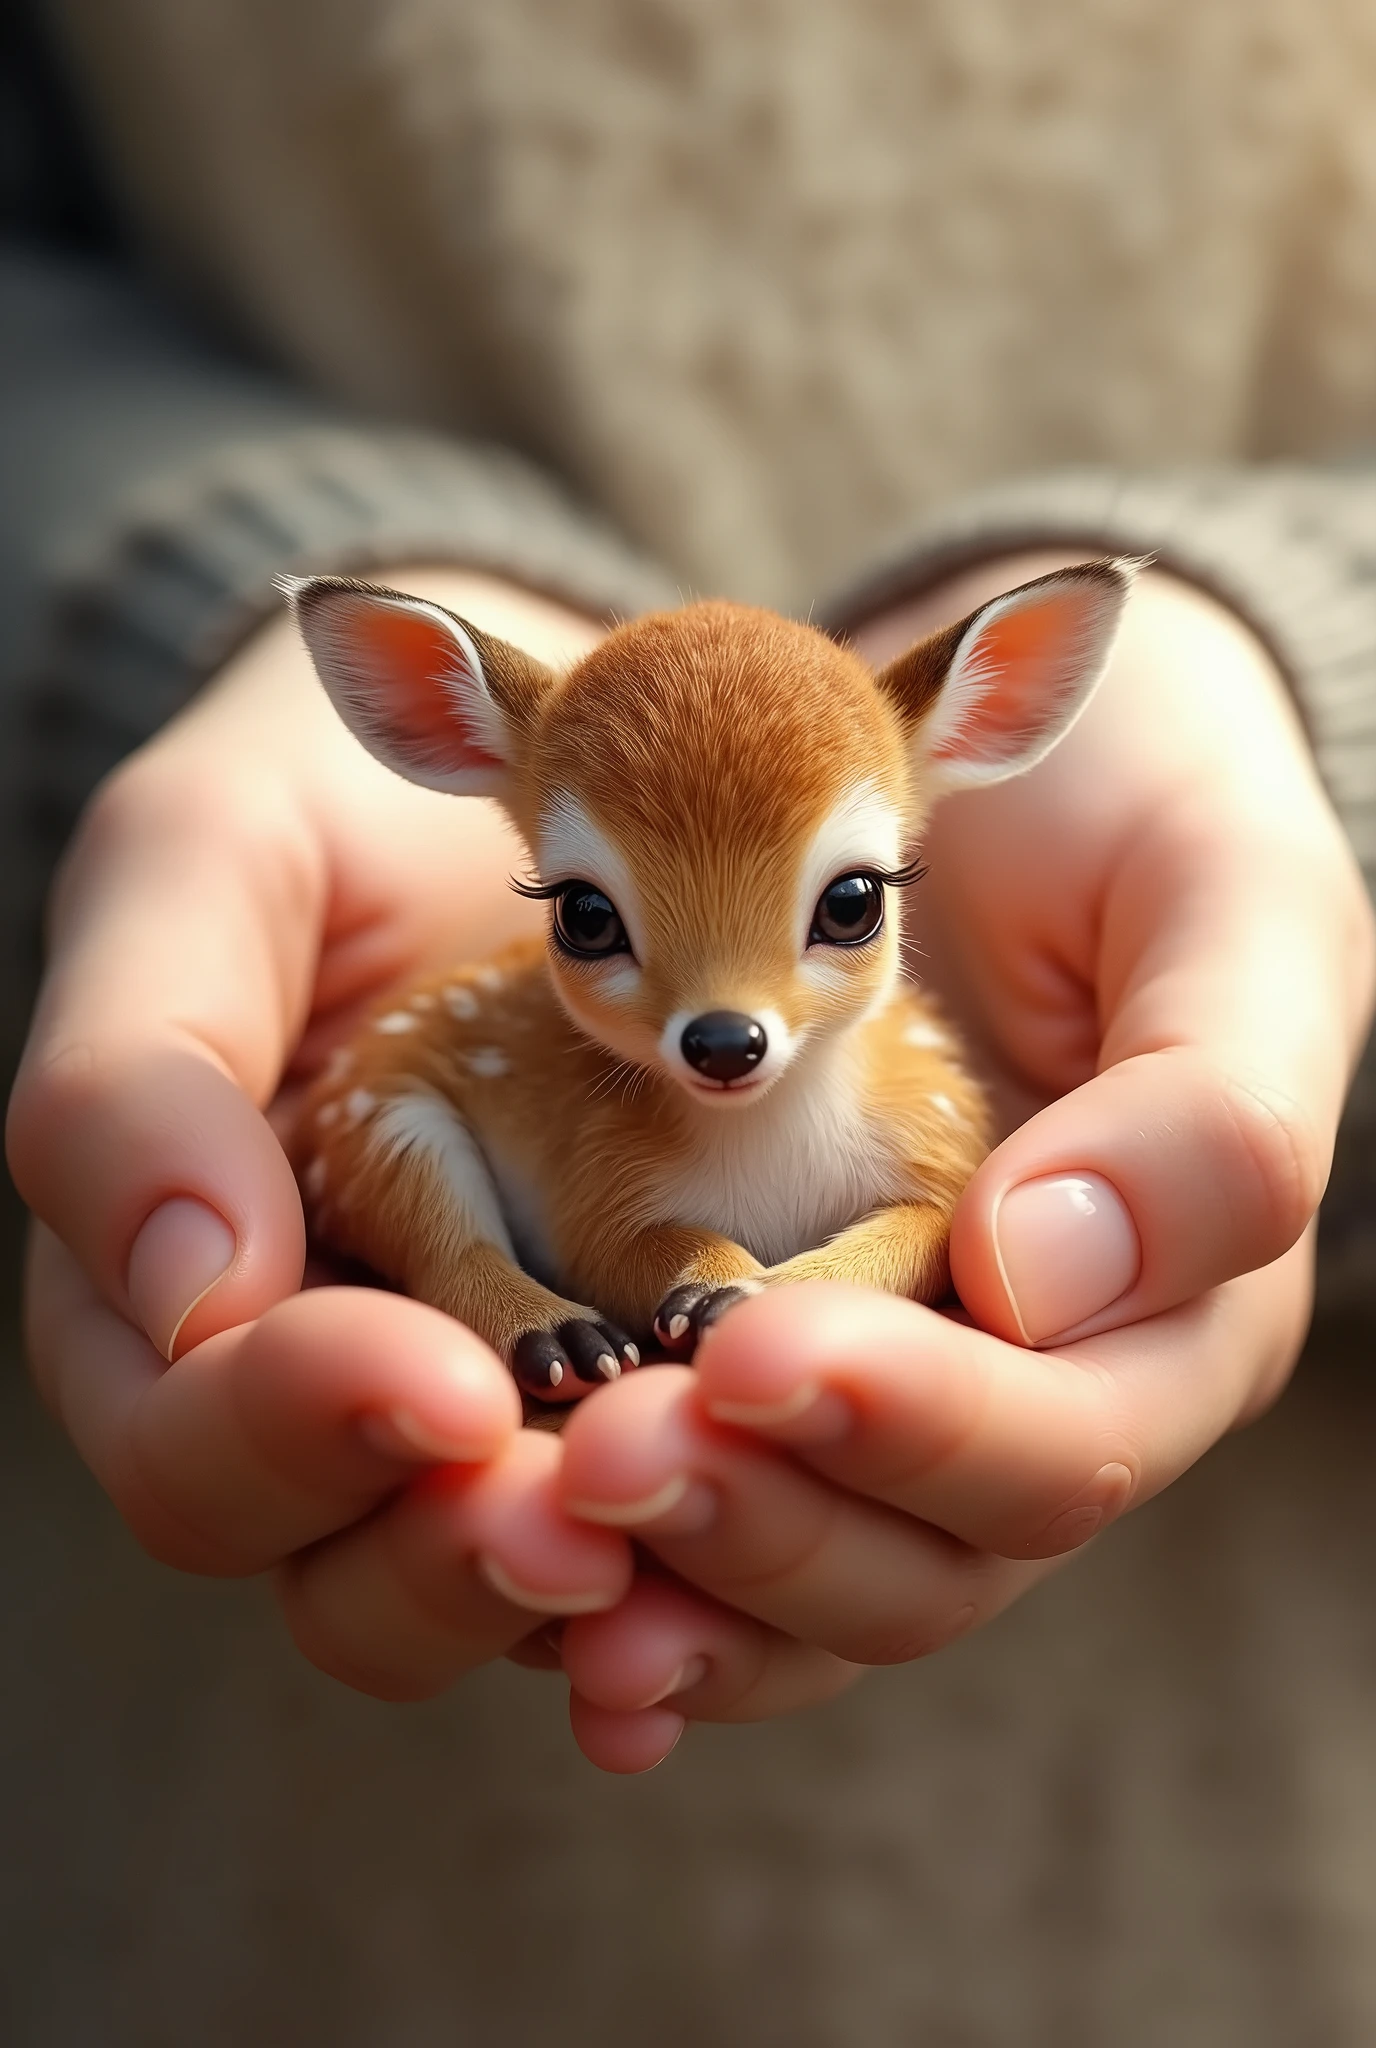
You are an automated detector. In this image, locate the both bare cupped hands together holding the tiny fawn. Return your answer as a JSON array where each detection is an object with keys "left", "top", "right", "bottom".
[{"left": 8, "top": 555, "right": 1374, "bottom": 1769}]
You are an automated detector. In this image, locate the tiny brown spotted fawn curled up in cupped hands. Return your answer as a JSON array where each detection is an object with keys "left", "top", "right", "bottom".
[{"left": 291, "top": 561, "right": 1132, "bottom": 1403}]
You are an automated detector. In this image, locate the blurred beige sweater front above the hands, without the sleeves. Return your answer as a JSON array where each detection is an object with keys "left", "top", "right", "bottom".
[{"left": 57, "top": 0, "right": 1376, "bottom": 604}]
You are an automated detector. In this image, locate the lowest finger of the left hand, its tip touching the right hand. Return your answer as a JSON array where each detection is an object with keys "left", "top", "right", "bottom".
[{"left": 278, "top": 1430, "right": 633, "bottom": 1700}]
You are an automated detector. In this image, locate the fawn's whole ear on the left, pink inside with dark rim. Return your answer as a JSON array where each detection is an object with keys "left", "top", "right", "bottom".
[{"left": 283, "top": 575, "right": 555, "bottom": 797}]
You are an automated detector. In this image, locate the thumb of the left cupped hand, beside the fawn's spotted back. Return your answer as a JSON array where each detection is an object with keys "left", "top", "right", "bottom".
[{"left": 6, "top": 760, "right": 326, "bottom": 1356}]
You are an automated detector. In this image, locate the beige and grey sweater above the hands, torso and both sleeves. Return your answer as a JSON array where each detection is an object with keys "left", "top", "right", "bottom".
[{"left": 0, "top": 0, "right": 1376, "bottom": 1272}]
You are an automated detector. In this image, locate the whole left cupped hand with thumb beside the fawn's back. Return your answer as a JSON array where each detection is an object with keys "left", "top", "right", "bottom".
[{"left": 8, "top": 571, "right": 651, "bottom": 1698}]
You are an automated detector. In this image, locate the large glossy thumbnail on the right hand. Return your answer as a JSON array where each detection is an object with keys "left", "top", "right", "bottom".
[{"left": 993, "top": 1174, "right": 1143, "bottom": 1343}]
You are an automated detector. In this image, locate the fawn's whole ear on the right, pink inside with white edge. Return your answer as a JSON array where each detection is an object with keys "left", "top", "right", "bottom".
[{"left": 878, "top": 561, "right": 1138, "bottom": 795}]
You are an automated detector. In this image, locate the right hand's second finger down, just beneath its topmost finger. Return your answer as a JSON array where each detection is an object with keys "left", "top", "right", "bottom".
[{"left": 561, "top": 1359, "right": 1028, "bottom": 1663}]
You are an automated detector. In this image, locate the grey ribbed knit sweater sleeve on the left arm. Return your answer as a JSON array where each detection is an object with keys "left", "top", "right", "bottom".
[{"left": 0, "top": 248, "right": 678, "bottom": 1056}]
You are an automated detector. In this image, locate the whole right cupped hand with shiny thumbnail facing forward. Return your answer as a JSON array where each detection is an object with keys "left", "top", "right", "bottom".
[{"left": 559, "top": 557, "right": 1372, "bottom": 1749}]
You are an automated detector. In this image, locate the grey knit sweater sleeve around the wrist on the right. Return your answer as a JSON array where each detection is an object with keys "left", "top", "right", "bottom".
[{"left": 823, "top": 465, "right": 1376, "bottom": 1313}]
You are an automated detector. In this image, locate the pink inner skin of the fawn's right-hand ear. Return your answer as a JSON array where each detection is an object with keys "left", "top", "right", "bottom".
[{"left": 932, "top": 590, "right": 1089, "bottom": 762}]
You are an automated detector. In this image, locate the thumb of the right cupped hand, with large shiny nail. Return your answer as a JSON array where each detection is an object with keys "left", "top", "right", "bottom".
[{"left": 950, "top": 803, "right": 1370, "bottom": 1343}]
